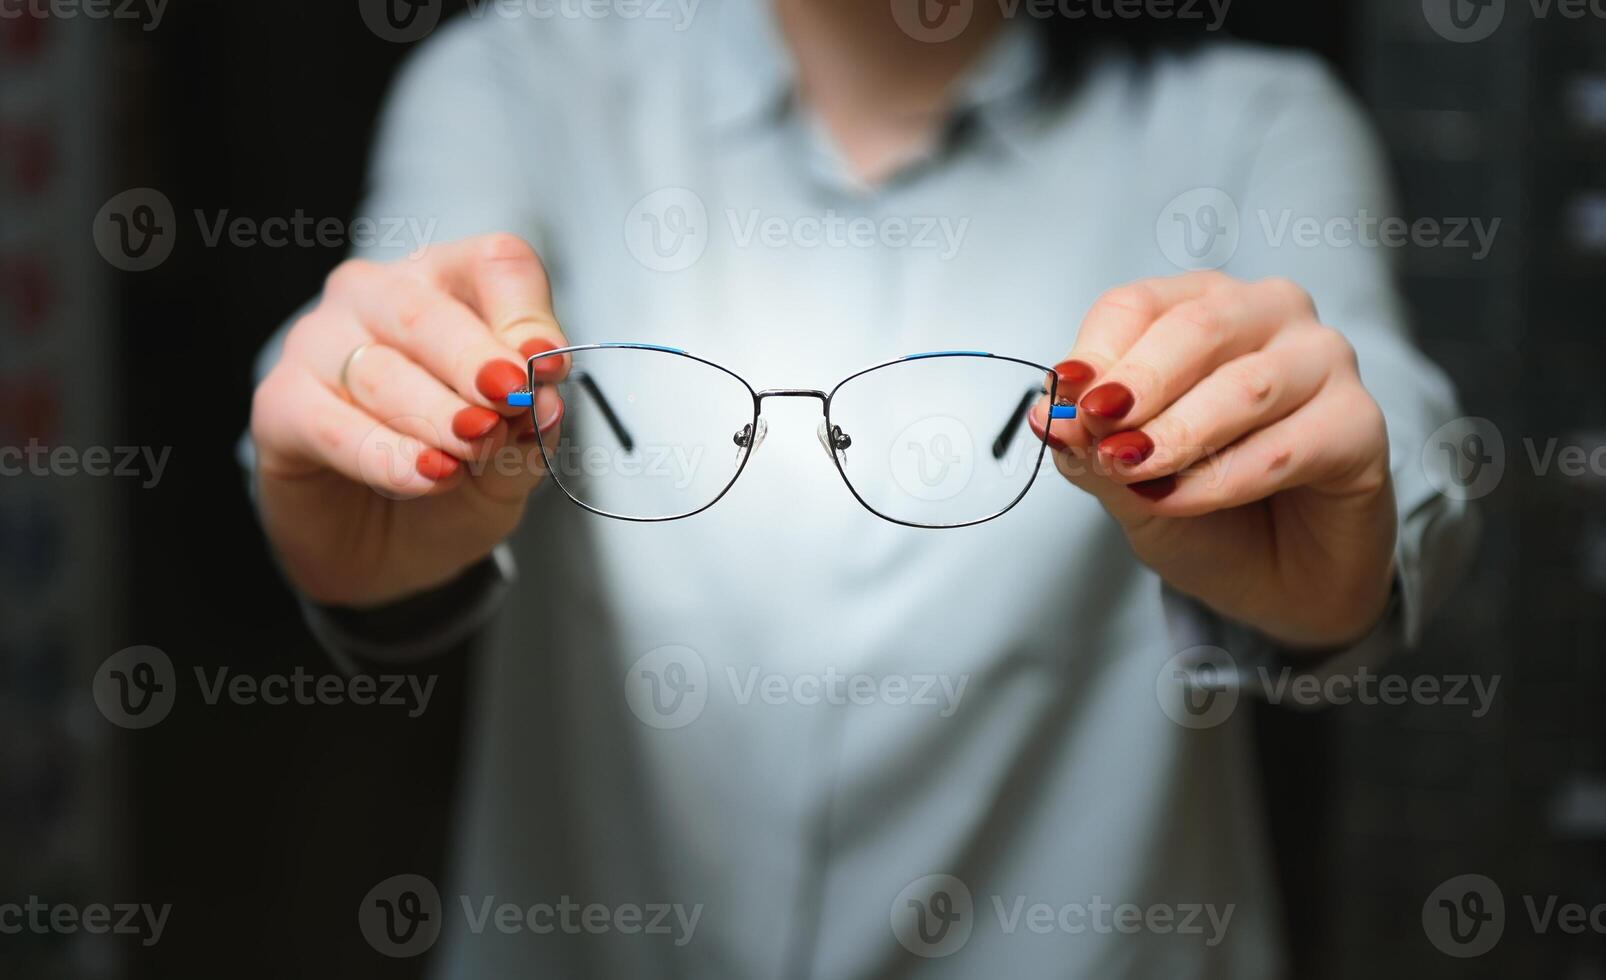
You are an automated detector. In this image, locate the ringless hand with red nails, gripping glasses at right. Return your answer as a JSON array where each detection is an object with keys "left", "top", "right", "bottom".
[{"left": 1031, "top": 273, "right": 1396, "bottom": 647}]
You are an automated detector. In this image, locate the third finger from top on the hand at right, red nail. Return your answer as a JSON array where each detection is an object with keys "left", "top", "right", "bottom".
[{"left": 1097, "top": 328, "right": 1351, "bottom": 484}]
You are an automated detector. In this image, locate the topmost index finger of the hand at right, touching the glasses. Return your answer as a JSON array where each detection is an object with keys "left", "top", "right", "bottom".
[{"left": 1039, "top": 273, "right": 1225, "bottom": 448}]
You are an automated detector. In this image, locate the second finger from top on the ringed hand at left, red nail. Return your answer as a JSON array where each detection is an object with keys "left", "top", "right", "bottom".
[{"left": 324, "top": 260, "right": 527, "bottom": 416}]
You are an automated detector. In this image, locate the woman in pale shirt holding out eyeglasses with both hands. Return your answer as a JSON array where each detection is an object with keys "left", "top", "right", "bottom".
[{"left": 252, "top": 0, "right": 1469, "bottom": 977}]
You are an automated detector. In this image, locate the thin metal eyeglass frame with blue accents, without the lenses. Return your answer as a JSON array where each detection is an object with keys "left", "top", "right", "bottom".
[{"left": 507, "top": 344, "right": 1076, "bottom": 530}]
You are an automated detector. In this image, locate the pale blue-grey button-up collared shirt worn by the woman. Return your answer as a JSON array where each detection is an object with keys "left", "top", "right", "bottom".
[{"left": 282, "top": 0, "right": 1466, "bottom": 978}]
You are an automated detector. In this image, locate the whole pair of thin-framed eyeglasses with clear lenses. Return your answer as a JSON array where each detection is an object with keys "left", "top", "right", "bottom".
[{"left": 507, "top": 344, "right": 1076, "bottom": 527}]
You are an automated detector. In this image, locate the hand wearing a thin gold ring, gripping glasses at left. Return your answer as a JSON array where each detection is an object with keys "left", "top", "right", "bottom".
[{"left": 251, "top": 235, "right": 567, "bottom": 607}]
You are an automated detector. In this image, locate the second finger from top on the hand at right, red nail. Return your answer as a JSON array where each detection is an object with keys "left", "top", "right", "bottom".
[{"left": 1078, "top": 281, "right": 1315, "bottom": 437}]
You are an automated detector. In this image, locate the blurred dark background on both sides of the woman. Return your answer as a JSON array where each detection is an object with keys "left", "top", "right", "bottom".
[{"left": 0, "top": 0, "right": 1606, "bottom": 980}]
